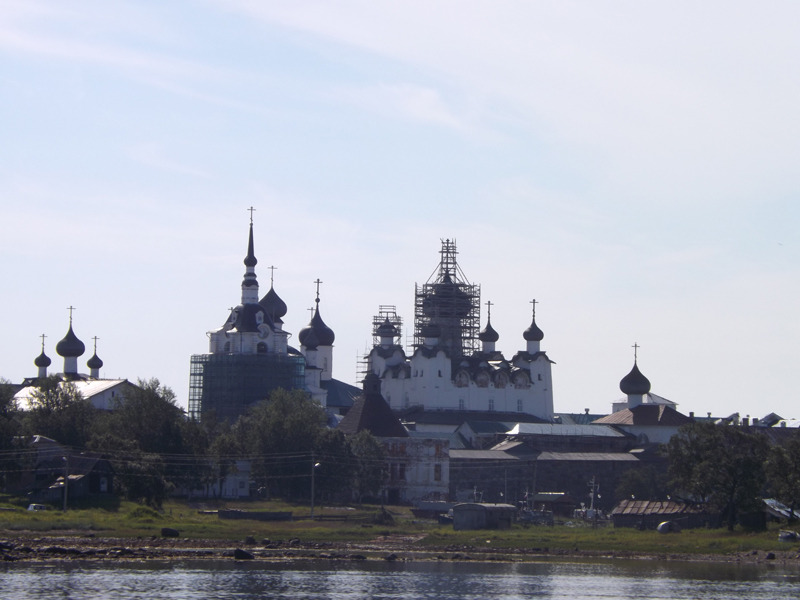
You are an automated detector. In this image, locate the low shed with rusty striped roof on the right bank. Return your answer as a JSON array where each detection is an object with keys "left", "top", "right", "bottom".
[{"left": 611, "top": 500, "right": 714, "bottom": 529}]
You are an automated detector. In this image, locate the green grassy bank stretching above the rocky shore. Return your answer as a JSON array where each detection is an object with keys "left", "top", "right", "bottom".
[{"left": 0, "top": 498, "right": 798, "bottom": 556}]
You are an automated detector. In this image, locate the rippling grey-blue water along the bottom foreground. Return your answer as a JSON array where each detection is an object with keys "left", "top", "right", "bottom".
[{"left": 0, "top": 560, "right": 800, "bottom": 600}]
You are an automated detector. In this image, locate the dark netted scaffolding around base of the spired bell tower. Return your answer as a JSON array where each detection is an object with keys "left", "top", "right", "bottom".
[{"left": 189, "top": 353, "right": 305, "bottom": 421}]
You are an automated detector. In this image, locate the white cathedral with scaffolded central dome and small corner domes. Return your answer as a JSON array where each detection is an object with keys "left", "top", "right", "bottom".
[{"left": 367, "top": 240, "right": 553, "bottom": 421}]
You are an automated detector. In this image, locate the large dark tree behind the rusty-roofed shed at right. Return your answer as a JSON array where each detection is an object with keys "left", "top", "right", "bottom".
[{"left": 667, "top": 422, "right": 767, "bottom": 530}]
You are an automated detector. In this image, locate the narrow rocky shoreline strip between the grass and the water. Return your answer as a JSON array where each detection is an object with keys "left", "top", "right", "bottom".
[{"left": 0, "top": 535, "right": 800, "bottom": 569}]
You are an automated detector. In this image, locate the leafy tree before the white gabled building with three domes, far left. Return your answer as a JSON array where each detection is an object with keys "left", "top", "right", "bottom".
[{"left": 25, "top": 375, "right": 98, "bottom": 448}]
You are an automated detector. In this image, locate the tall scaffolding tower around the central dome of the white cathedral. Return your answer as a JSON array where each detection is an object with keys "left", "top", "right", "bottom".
[{"left": 414, "top": 239, "right": 481, "bottom": 358}]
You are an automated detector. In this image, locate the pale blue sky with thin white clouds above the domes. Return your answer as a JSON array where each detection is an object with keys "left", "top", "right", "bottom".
[{"left": 0, "top": 0, "right": 800, "bottom": 418}]
